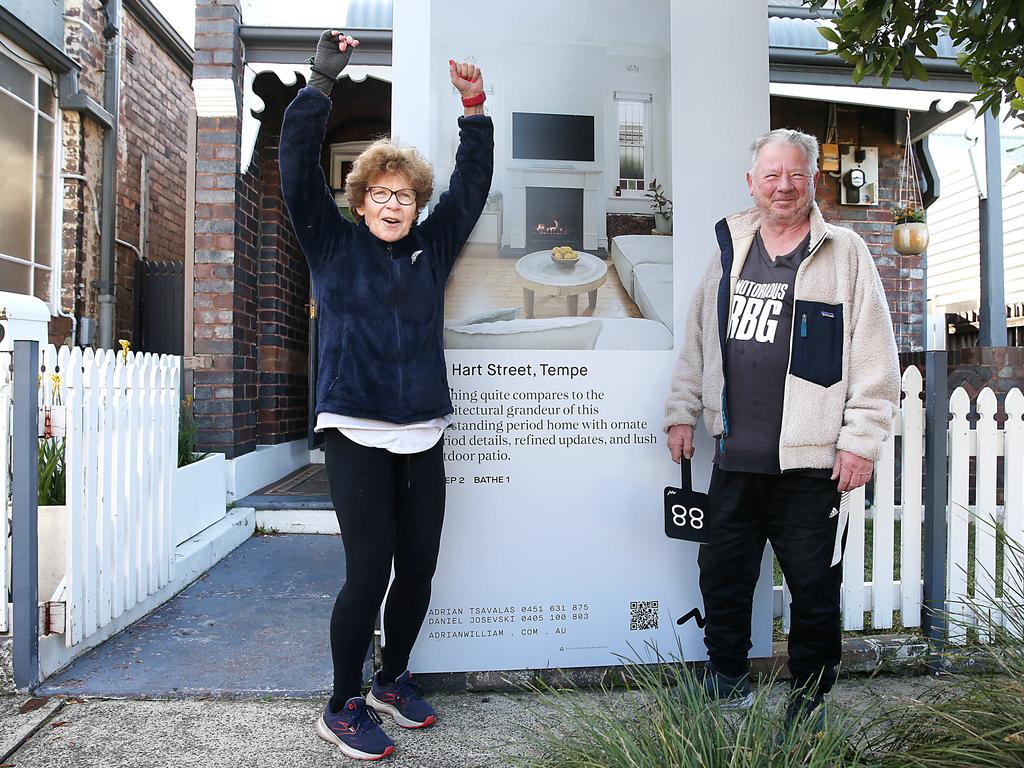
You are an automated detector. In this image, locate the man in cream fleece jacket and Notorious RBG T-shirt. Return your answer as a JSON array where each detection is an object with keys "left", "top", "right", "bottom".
[{"left": 665, "top": 129, "right": 899, "bottom": 727}]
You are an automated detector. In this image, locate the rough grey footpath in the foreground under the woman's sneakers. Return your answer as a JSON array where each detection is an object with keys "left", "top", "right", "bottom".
[{"left": 0, "top": 678, "right": 929, "bottom": 768}]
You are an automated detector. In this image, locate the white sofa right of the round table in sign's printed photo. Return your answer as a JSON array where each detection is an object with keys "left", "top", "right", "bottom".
[{"left": 611, "top": 234, "right": 673, "bottom": 331}]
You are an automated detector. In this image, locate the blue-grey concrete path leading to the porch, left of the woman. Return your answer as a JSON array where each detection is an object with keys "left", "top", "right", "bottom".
[{"left": 38, "top": 536, "right": 345, "bottom": 698}]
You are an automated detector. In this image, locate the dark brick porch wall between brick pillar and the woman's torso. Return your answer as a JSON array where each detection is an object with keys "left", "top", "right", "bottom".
[{"left": 253, "top": 131, "right": 309, "bottom": 444}]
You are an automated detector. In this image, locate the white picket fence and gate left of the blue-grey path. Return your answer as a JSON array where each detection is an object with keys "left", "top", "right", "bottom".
[{"left": 0, "top": 346, "right": 181, "bottom": 647}]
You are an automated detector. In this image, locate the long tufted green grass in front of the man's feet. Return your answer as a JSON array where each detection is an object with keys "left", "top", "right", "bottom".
[{"left": 510, "top": 651, "right": 864, "bottom": 768}]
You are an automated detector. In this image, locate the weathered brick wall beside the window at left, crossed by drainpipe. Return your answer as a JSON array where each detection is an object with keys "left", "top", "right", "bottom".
[{"left": 50, "top": 0, "right": 194, "bottom": 343}]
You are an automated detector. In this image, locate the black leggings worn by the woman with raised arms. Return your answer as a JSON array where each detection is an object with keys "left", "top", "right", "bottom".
[{"left": 324, "top": 429, "right": 444, "bottom": 703}]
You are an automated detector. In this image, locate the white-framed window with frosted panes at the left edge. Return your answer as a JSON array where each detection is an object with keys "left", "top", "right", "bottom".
[{"left": 0, "top": 38, "right": 56, "bottom": 304}]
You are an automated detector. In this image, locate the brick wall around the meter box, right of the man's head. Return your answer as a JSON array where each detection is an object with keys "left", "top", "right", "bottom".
[{"left": 771, "top": 96, "right": 926, "bottom": 351}]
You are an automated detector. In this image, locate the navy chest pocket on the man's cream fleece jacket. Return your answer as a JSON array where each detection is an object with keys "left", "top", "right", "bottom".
[{"left": 790, "top": 299, "right": 843, "bottom": 387}]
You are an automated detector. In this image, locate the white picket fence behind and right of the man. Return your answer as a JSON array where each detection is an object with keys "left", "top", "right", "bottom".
[{"left": 775, "top": 367, "right": 1024, "bottom": 643}]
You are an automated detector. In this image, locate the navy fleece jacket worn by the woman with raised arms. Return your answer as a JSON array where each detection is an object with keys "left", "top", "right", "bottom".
[{"left": 281, "top": 87, "right": 495, "bottom": 424}]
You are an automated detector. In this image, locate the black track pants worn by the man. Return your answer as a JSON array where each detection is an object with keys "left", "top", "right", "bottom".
[{"left": 697, "top": 467, "right": 843, "bottom": 692}]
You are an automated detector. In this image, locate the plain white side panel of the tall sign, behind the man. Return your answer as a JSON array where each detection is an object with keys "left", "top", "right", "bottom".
[{"left": 672, "top": 0, "right": 772, "bottom": 656}]
